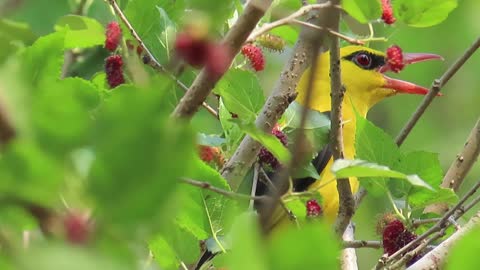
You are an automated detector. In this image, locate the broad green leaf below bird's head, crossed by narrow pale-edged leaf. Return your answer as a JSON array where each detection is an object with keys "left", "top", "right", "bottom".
[{"left": 355, "top": 114, "right": 401, "bottom": 195}]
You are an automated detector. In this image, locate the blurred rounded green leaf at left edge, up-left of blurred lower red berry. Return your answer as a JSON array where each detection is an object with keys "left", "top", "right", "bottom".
[{"left": 0, "top": 141, "right": 63, "bottom": 206}]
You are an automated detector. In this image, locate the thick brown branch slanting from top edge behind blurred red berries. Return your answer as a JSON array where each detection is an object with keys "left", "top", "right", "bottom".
[{"left": 172, "top": 0, "right": 272, "bottom": 119}]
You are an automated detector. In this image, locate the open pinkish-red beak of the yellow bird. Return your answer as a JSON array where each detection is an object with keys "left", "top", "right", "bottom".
[{"left": 379, "top": 53, "right": 443, "bottom": 96}]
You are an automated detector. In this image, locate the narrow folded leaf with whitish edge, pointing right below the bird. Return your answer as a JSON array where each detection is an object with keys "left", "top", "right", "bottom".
[{"left": 332, "top": 159, "right": 434, "bottom": 191}]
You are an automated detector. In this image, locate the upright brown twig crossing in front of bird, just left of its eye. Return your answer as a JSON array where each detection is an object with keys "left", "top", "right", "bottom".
[{"left": 330, "top": 1, "right": 355, "bottom": 236}]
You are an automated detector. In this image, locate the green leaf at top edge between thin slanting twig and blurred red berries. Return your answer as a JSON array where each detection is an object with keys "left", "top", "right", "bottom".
[{"left": 124, "top": 0, "right": 185, "bottom": 62}]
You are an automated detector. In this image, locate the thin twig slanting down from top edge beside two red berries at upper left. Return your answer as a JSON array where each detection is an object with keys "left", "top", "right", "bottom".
[{"left": 107, "top": 0, "right": 218, "bottom": 119}]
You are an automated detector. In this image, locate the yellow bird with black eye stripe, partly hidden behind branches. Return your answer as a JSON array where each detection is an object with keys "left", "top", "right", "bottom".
[{"left": 288, "top": 46, "right": 441, "bottom": 221}]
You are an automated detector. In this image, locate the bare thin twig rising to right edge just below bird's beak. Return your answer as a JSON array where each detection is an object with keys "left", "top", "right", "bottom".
[{"left": 395, "top": 38, "right": 480, "bottom": 146}]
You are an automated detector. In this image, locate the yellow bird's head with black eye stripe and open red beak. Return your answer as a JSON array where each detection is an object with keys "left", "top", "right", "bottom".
[{"left": 340, "top": 46, "right": 442, "bottom": 107}]
